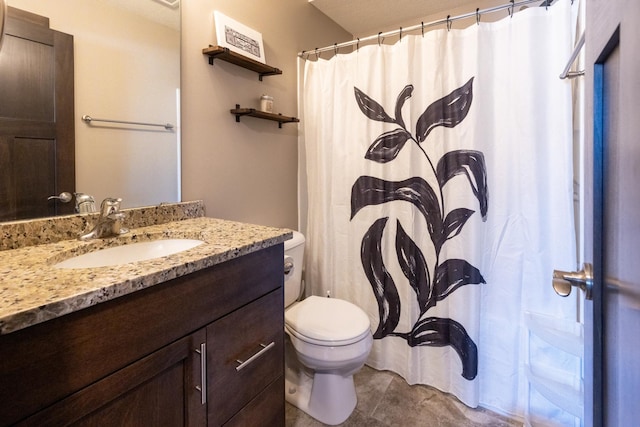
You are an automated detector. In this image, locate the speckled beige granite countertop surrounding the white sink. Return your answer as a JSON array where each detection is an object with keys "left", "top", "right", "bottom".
[{"left": 0, "top": 217, "right": 291, "bottom": 335}]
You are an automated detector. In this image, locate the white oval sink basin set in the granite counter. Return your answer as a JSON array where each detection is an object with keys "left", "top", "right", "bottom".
[{"left": 54, "top": 239, "right": 204, "bottom": 268}]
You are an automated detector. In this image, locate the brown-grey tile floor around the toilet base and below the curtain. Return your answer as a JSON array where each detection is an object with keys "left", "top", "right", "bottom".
[{"left": 286, "top": 366, "right": 522, "bottom": 427}]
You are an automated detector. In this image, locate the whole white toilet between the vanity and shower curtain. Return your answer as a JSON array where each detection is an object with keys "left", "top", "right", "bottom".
[{"left": 284, "top": 232, "right": 373, "bottom": 425}]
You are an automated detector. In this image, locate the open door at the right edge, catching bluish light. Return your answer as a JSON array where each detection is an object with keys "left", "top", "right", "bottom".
[{"left": 585, "top": 0, "right": 640, "bottom": 426}]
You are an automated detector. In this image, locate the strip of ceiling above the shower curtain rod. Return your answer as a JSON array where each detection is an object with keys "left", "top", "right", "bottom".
[{"left": 309, "top": 0, "right": 509, "bottom": 36}]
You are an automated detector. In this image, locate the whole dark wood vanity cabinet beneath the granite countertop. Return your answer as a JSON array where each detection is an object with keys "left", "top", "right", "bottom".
[{"left": 0, "top": 245, "right": 284, "bottom": 427}]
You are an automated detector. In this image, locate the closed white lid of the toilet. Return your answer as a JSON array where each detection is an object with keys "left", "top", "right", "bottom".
[{"left": 284, "top": 296, "right": 370, "bottom": 342}]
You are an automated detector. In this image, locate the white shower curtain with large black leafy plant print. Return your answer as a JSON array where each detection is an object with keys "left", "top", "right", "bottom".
[{"left": 300, "top": 0, "right": 576, "bottom": 422}]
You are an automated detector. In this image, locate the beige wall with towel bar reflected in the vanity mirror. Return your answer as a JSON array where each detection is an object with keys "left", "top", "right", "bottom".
[{"left": 0, "top": 0, "right": 180, "bottom": 221}]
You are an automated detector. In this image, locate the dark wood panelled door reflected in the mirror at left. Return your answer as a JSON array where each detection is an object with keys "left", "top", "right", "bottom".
[{"left": 0, "top": 7, "right": 75, "bottom": 221}]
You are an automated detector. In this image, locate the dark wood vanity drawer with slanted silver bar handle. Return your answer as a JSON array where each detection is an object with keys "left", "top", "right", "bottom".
[{"left": 207, "top": 288, "right": 284, "bottom": 426}]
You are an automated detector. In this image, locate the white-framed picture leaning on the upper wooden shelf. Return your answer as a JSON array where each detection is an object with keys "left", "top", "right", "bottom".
[{"left": 213, "top": 10, "right": 265, "bottom": 64}]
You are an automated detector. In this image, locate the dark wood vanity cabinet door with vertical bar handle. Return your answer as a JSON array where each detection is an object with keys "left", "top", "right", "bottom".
[{"left": 18, "top": 329, "right": 207, "bottom": 427}]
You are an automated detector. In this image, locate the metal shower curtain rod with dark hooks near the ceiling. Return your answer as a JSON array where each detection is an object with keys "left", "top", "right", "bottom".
[{"left": 298, "top": 0, "right": 556, "bottom": 59}]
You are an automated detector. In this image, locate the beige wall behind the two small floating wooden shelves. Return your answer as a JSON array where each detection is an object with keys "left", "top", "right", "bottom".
[{"left": 181, "top": 0, "right": 351, "bottom": 228}]
